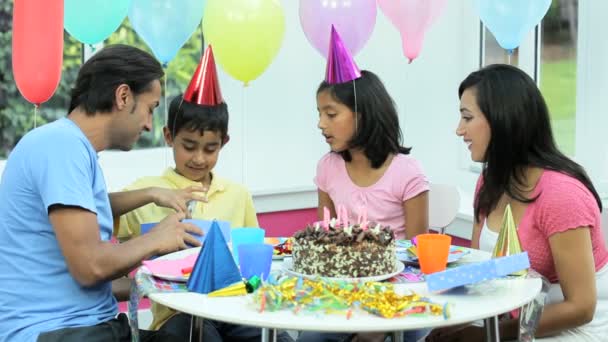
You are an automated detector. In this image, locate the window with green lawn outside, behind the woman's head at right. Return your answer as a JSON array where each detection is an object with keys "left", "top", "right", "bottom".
[{"left": 461, "top": 0, "right": 578, "bottom": 172}]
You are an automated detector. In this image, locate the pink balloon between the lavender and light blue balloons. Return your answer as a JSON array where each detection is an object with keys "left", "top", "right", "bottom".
[{"left": 378, "top": 0, "right": 447, "bottom": 63}]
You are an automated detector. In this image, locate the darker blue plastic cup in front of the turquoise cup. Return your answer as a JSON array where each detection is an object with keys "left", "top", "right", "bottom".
[{"left": 238, "top": 243, "right": 274, "bottom": 280}]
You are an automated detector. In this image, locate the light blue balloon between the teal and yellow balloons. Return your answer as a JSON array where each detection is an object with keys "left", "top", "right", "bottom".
[{"left": 129, "top": 0, "right": 205, "bottom": 65}]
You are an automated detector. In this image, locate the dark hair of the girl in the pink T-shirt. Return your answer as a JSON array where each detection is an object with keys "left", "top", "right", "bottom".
[{"left": 317, "top": 70, "right": 411, "bottom": 169}]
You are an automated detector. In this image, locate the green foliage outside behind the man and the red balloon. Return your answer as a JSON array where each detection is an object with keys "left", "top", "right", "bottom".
[{"left": 0, "top": 0, "right": 202, "bottom": 159}]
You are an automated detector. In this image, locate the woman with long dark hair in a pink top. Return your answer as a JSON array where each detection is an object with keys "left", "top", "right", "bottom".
[{"left": 442, "top": 65, "right": 608, "bottom": 341}]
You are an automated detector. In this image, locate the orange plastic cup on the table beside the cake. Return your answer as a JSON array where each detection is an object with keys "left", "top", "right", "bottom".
[{"left": 416, "top": 234, "right": 452, "bottom": 274}]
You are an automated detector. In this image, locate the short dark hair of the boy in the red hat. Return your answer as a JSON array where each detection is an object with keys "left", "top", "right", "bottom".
[{"left": 167, "top": 94, "right": 228, "bottom": 143}]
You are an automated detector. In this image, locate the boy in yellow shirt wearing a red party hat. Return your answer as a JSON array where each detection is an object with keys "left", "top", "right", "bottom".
[{"left": 117, "top": 47, "right": 292, "bottom": 341}]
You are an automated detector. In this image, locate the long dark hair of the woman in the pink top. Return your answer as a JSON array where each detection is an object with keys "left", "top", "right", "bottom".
[{"left": 458, "top": 64, "right": 602, "bottom": 222}]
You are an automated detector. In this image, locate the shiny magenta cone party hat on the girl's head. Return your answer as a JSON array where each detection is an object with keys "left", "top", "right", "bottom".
[{"left": 325, "top": 25, "right": 361, "bottom": 84}]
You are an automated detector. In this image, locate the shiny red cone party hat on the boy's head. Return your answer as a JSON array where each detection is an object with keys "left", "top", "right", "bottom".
[{"left": 184, "top": 45, "right": 224, "bottom": 106}]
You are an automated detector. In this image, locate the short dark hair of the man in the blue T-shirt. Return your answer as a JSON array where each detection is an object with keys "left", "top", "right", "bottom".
[{"left": 69, "top": 44, "right": 164, "bottom": 115}]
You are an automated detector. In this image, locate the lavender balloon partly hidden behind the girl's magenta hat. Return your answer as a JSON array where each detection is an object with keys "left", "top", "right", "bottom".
[{"left": 300, "top": 0, "right": 377, "bottom": 57}]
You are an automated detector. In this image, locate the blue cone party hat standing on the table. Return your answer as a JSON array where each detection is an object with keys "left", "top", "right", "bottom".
[{"left": 187, "top": 221, "right": 243, "bottom": 294}]
